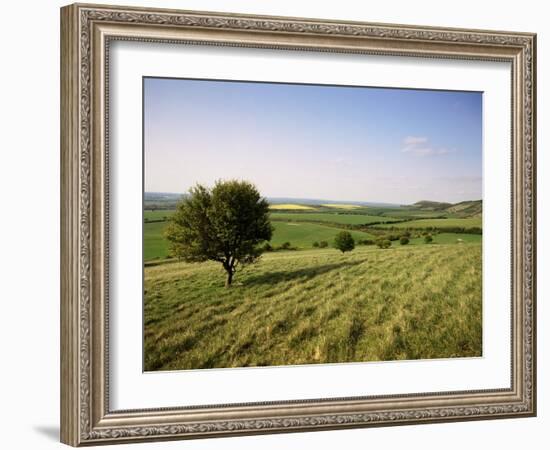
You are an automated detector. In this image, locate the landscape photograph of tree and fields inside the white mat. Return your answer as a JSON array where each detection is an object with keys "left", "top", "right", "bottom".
[{"left": 141, "top": 77, "right": 483, "bottom": 371}]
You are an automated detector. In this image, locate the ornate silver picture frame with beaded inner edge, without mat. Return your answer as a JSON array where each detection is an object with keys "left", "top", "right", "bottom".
[{"left": 61, "top": 4, "right": 536, "bottom": 446}]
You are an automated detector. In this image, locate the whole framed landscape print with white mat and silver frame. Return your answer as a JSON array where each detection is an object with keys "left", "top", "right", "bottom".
[{"left": 61, "top": 4, "right": 536, "bottom": 446}]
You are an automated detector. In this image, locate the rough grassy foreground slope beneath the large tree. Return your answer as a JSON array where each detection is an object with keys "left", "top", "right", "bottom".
[{"left": 144, "top": 244, "right": 482, "bottom": 371}]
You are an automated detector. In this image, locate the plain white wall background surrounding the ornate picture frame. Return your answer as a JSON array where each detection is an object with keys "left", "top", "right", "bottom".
[{"left": 0, "top": 0, "right": 550, "bottom": 450}]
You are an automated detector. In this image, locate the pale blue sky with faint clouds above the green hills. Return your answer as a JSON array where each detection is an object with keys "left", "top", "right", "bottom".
[{"left": 144, "top": 78, "right": 482, "bottom": 204}]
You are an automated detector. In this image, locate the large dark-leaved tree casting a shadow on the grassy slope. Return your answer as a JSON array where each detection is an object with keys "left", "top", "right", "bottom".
[{"left": 166, "top": 180, "right": 273, "bottom": 287}]
